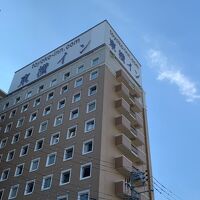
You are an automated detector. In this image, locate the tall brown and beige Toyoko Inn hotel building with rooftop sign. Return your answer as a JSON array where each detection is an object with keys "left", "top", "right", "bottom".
[{"left": 0, "top": 21, "right": 154, "bottom": 200}]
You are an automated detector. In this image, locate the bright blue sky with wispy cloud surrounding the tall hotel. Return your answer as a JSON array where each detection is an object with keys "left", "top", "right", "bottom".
[{"left": 0, "top": 0, "right": 200, "bottom": 200}]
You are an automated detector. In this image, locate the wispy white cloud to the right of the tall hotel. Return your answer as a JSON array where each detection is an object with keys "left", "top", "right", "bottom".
[{"left": 148, "top": 49, "right": 200, "bottom": 102}]
